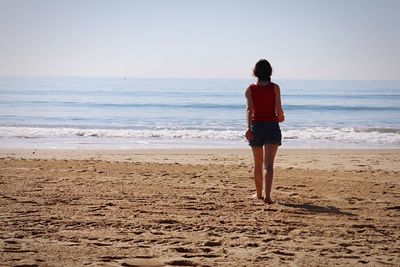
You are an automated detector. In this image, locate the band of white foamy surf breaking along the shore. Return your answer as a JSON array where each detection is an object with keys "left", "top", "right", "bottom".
[{"left": 0, "top": 126, "right": 400, "bottom": 148}]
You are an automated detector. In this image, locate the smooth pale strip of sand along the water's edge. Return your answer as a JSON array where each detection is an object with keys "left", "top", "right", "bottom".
[{"left": 0, "top": 148, "right": 400, "bottom": 171}]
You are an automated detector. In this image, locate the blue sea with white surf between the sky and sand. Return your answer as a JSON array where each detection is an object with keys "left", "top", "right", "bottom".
[{"left": 0, "top": 76, "right": 400, "bottom": 149}]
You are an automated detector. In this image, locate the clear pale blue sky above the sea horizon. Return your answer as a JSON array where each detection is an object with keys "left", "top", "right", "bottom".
[{"left": 0, "top": 0, "right": 400, "bottom": 80}]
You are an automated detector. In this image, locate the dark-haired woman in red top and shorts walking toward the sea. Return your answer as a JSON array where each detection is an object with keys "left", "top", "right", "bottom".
[{"left": 245, "top": 59, "right": 285, "bottom": 204}]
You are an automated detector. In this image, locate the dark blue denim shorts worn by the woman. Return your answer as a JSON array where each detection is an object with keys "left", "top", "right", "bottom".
[{"left": 249, "top": 122, "right": 282, "bottom": 147}]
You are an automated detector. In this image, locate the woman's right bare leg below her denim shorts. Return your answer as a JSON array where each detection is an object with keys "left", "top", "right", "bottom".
[{"left": 264, "top": 144, "right": 279, "bottom": 204}]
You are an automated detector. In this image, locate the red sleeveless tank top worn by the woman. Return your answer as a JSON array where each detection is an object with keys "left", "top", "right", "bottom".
[{"left": 250, "top": 83, "right": 278, "bottom": 122}]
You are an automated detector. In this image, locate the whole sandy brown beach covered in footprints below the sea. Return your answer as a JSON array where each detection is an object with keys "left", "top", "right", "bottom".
[{"left": 0, "top": 149, "right": 400, "bottom": 266}]
